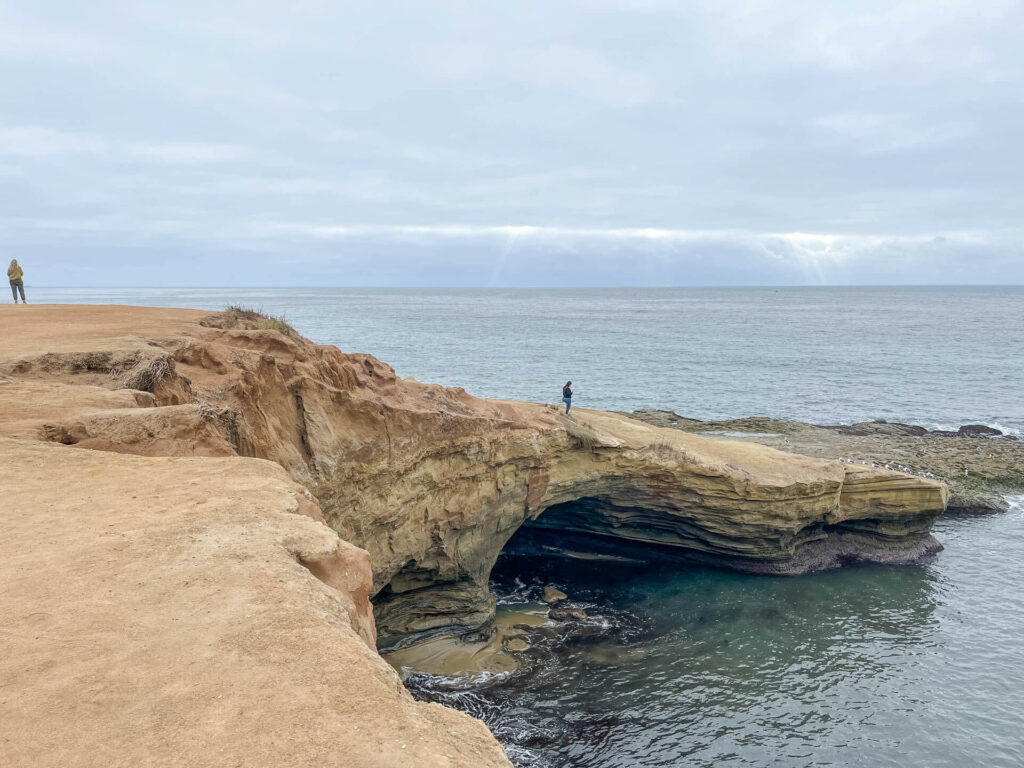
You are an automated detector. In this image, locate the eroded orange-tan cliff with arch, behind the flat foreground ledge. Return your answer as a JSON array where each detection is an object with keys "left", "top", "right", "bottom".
[{"left": 0, "top": 307, "right": 946, "bottom": 663}]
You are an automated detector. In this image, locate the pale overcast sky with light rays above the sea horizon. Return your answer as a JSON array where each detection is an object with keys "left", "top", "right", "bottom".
[{"left": 0, "top": 0, "right": 1024, "bottom": 287}]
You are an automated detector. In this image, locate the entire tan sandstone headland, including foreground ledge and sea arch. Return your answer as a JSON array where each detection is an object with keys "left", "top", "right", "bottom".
[{"left": 0, "top": 305, "right": 947, "bottom": 768}]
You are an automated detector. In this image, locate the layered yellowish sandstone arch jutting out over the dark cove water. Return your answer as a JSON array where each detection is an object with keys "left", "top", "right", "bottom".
[{"left": 362, "top": 413, "right": 945, "bottom": 647}]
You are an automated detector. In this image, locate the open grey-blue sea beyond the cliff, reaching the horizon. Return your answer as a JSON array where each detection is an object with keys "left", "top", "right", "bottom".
[{"left": 32, "top": 287, "right": 1024, "bottom": 431}]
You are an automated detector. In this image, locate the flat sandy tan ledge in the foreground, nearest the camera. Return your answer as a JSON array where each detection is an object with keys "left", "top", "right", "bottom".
[{"left": 0, "top": 439, "right": 508, "bottom": 768}]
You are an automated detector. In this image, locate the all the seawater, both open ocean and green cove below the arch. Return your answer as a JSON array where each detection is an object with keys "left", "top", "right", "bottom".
[{"left": 29, "top": 287, "right": 1024, "bottom": 768}]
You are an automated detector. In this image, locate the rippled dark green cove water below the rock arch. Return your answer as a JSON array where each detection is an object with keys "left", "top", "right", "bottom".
[{"left": 411, "top": 505, "right": 1024, "bottom": 768}]
